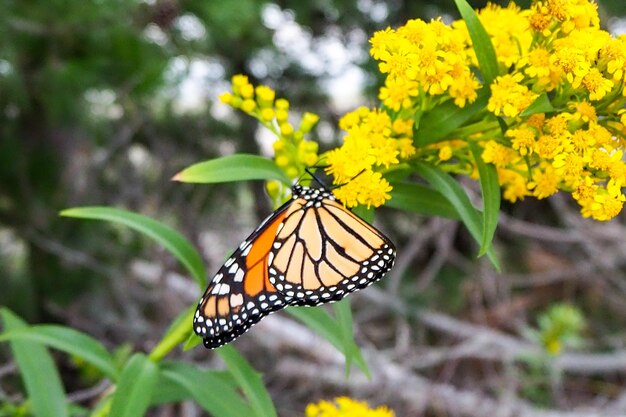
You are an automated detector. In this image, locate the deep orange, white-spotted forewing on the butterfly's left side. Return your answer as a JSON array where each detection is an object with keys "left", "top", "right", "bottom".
[{"left": 193, "top": 202, "right": 290, "bottom": 349}]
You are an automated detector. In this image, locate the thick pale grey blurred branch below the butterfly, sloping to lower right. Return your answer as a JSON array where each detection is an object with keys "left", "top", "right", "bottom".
[{"left": 252, "top": 316, "right": 624, "bottom": 417}]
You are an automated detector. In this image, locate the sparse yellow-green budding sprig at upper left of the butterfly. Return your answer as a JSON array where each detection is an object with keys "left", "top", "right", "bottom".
[{"left": 220, "top": 75, "right": 319, "bottom": 180}]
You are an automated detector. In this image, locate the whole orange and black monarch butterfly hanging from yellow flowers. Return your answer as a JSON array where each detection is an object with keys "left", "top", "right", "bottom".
[{"left": 193, "top": 185, "right": 395, "bottom": 349}]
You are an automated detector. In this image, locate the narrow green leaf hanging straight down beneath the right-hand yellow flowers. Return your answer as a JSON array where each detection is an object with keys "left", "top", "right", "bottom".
[{"left": 469, "top": 141, "right": 500, "bottom": 256}]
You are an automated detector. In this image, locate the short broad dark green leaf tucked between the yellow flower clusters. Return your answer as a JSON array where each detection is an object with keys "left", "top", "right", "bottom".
[{"left": 414, "top": 87, "right": 489, "bottom": 147}]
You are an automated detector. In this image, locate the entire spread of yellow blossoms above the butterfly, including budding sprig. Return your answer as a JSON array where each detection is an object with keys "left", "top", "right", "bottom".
[{"left": 222, "top": 0, "right": 626, "bottom": 220}]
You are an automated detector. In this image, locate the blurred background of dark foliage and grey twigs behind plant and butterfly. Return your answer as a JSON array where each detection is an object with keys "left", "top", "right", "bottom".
[{"left": 0, "top": 0, "right": 626, "bottom": 416}]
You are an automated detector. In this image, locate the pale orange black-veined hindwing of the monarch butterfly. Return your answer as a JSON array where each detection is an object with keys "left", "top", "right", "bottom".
[{"left": 269, "top": 187, "right": 395, "bottom": 306}]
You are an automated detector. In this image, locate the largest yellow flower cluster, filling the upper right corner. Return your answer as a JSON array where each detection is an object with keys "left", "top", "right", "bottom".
[{"left": 468, "top": 0, "right": 626, "bottom": 220}]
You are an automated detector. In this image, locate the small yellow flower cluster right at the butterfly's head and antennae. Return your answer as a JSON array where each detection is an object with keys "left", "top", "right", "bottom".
[{"left": 325, "top": 107, "right": 415, "bottom": 208}]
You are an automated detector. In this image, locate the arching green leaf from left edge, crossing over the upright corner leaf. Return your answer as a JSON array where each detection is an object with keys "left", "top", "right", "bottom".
[{"left": 0, "top": 325, "right": 119, "bottom": 380}]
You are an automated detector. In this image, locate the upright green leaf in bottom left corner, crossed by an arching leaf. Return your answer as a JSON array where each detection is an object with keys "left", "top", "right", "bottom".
[{"left": 0, "top": 308, "right": 68, "bottom": 417}]
